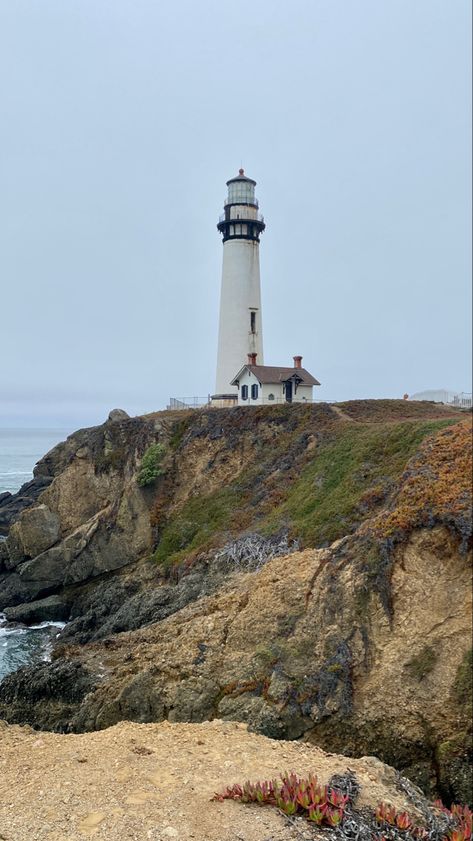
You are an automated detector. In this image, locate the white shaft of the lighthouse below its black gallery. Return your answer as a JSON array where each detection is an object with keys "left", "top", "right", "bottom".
[{"left": 215, "top": 239, "right": 264, "bottom": 394}]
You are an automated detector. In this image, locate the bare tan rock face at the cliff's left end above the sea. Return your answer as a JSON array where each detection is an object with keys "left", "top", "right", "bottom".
[{"left": 0, "top": 419, "right": 159, "bottom": 608}]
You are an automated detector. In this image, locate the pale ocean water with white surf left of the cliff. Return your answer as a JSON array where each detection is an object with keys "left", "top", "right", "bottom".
[{"left": 0, "top": 429, "right": 72, "bottom": 681}]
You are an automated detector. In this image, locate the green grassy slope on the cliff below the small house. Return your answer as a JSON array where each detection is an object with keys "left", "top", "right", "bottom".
[{"left": 151, "top": 401, "right": 464, "bottom": 566}]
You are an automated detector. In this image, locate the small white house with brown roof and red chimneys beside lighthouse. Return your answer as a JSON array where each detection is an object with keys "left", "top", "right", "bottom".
[{"left": 231, "top": 353, "right": 320, "bottom": 406}]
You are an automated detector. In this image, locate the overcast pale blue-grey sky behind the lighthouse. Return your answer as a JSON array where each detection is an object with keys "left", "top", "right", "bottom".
[{"left": 0, "top": 0, "right": 471, "bottom": 426}]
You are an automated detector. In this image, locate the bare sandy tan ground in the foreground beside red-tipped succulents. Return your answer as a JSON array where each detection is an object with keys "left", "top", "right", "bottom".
[{"left": 0, "top": 721, "right": 412, "bottom": 841}]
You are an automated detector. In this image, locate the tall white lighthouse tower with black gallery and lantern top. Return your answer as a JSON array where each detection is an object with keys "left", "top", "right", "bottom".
[{"left": 212, "top": 169, "right": 265, "bottom": 406}]
